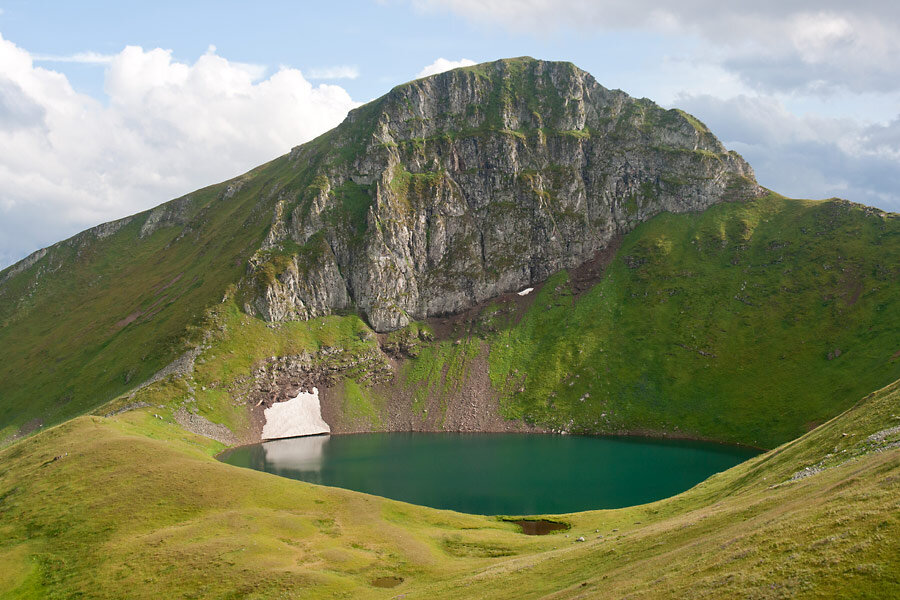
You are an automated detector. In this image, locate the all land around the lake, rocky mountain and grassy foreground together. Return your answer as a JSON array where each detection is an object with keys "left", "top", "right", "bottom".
[{"left": 0, "top": 58, "right": 900, "bottom": 598}]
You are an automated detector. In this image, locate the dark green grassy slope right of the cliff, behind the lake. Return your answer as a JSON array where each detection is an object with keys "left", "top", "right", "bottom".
[{"left": 468, "top": 195, "right": 900, "bottom": 448}]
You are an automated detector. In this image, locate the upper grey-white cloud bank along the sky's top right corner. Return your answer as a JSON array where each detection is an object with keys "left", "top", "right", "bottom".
[{"left": 410, "top": 0, "right": 900, "bottom": 93}]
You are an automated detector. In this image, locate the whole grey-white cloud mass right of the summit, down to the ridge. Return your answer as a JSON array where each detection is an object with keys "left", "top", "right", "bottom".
[{"left": 407, "top": 0, "right": 900, "bottom": 210}]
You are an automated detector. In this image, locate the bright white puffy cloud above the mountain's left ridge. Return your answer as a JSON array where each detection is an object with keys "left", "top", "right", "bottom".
[{"left": 0, "top": 36, "right": 357, "bottom": 268}]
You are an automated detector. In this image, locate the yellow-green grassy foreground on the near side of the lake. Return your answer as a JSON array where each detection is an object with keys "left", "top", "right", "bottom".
[{"left": 0, "top": 382, "right": 900, "bottom": 598}]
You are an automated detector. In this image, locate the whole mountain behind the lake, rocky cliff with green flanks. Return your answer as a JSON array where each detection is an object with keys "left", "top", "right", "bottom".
[{"left": 0, "top": 58, "right": 900, "bottom": 446}]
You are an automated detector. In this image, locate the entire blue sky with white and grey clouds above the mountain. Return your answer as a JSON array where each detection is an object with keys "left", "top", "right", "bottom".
[{"left": 0, "top": 0, "right": 900, "bottom": 269}]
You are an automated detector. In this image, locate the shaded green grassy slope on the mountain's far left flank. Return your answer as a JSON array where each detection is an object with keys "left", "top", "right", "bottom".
[{"left": 0, "top": 158, "right": 296, "bottom": 442}]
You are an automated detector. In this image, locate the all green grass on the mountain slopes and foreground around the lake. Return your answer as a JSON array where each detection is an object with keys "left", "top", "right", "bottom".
[{"left": 0, "top": 59, "right": 900, "bottom": 598}]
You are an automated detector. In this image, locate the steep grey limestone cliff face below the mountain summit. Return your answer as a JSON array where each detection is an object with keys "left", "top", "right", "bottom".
[{"left": 249, "top": 58, "right": 763, "bottom": 331}]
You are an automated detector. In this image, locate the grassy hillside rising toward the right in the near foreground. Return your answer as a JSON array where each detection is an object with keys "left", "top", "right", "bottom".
[{"left": 426, "top": 382, "right": 900, "bottom": 598}]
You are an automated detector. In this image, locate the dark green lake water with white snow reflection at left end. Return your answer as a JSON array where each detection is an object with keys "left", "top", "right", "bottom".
[{"left": 220, "top": 433, "right": 758, "bottom": 515}]
